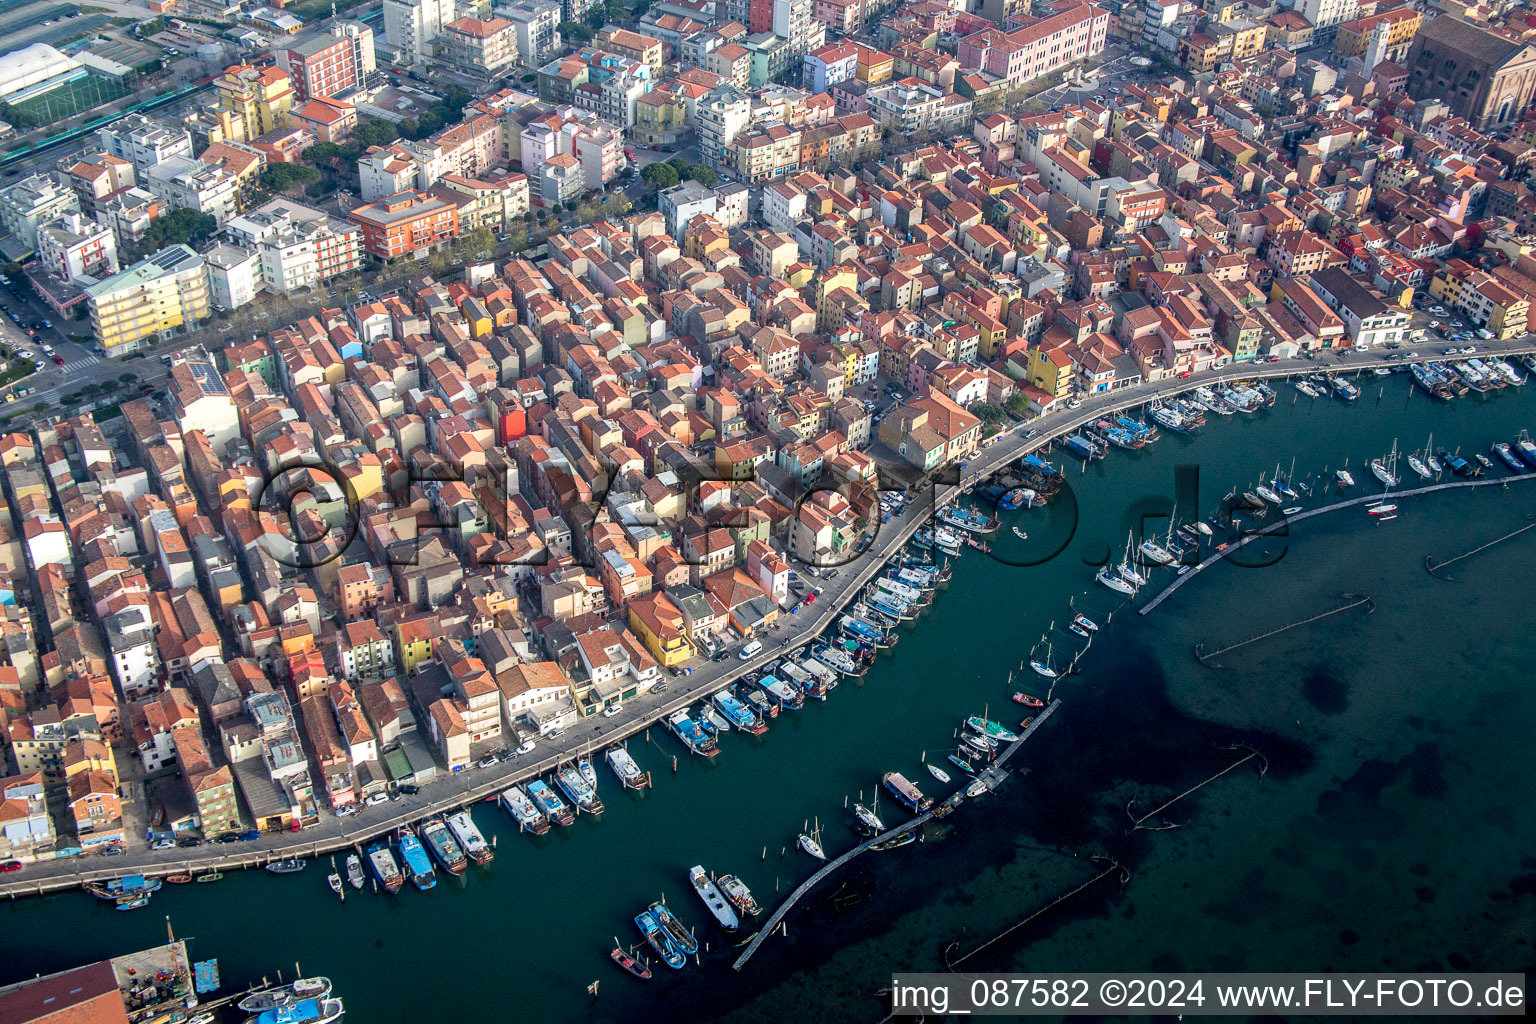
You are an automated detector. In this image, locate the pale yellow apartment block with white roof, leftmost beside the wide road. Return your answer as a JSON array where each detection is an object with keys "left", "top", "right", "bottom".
[{"left": 86, "top": 244, "right": 211, "bottom": 359}]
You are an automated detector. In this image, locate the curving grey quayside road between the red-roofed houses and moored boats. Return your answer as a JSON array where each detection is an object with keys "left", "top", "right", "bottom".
[{"left": 0, "top": 342, "right": 1536, "bottom": 897}]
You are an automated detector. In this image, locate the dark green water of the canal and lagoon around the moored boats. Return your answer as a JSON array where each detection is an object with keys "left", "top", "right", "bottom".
[{"left": 0, "top": 376, "right": 1536, "bottom": 1021}]
